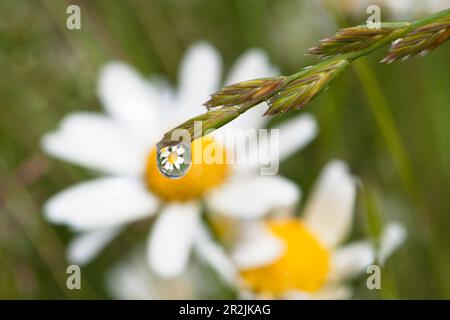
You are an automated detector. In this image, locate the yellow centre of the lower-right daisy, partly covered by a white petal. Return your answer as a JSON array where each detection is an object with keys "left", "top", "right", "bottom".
[{"left": 241, "top": 219, "right": 329, "bottom": 296}]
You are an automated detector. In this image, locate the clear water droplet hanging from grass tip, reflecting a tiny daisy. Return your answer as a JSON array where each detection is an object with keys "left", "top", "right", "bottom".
[{"left": 156, "top": 143, "right": 191, "bottom": 179}]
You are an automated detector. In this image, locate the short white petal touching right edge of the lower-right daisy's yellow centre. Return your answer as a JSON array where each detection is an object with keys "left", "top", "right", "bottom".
[{"left": 329, "top": 241, "right": 375, "bottom": 281}]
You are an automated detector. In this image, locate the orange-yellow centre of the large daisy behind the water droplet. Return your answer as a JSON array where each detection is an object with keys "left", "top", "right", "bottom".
[{"left": 145, "top": 138, "right": 228, "bottom": 202}]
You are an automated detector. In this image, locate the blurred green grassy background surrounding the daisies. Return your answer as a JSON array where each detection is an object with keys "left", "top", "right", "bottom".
[{"left": 0, "top": 0, "right": 450, "bottom": 299}]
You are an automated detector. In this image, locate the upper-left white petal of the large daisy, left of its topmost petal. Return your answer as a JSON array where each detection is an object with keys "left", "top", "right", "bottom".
[{"left": 98, "top": 62, "right": 161, "bottom": 141}]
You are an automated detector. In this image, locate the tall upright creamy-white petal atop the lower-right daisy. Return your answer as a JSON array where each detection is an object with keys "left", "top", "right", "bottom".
[{"left": 304, "top": 160, "right": 356, "bottom": 247}]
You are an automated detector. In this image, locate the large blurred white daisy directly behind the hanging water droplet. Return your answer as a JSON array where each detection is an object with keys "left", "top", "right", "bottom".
[{"left": 42, "top": 43, "right": 317, "bottom": 277}]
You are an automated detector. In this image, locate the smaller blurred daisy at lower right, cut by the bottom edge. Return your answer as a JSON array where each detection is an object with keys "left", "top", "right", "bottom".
[{"left": 199, "top": 160, "right": 406, "bottom": 299}]
